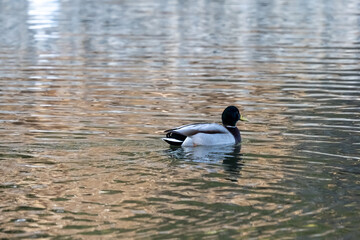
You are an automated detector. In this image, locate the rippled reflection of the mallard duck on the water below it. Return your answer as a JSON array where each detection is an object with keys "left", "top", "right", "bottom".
[{"left": 166, "top": 145, "right": 243, "bottom": 181}]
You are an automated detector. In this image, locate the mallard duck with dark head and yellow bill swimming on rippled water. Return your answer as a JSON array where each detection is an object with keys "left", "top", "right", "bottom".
[{"left": 162, "top": 106, "right": 248, "bottom": 147}]
